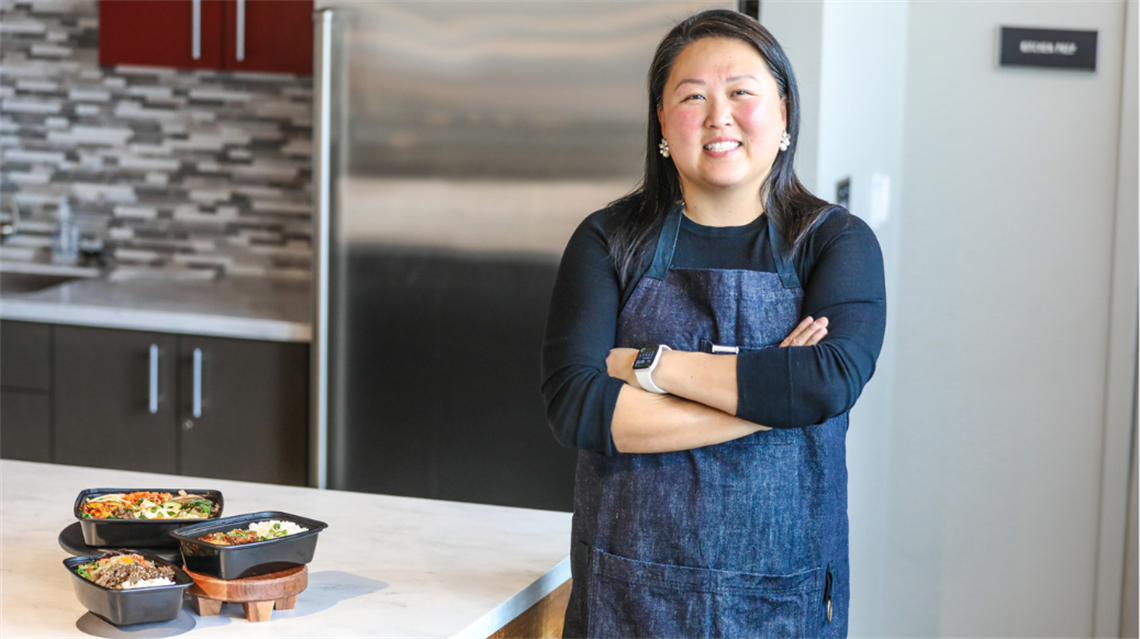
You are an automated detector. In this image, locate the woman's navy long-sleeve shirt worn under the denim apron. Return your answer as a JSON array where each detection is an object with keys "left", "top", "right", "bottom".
[{"left": 543, "top": 207, "right": 887, "bottom": 454}]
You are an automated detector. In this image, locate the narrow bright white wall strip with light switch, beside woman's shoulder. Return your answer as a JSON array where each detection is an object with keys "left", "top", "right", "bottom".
[{"left": 816, "top": 2, "right": 907, "bottom": 636}]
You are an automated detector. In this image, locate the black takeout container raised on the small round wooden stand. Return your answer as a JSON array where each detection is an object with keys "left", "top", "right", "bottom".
[{"left": 170, "top": 510, "right": 328, "bottom": 580}]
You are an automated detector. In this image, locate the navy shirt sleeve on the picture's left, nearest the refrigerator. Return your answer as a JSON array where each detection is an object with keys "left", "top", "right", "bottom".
[{"left": 543, "top": 212, "right": 625, "bottom": 454}]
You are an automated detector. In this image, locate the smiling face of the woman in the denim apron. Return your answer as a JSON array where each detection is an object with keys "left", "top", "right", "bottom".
[{"left": 657, "top": 38, "right": 788, "bottom": 203}]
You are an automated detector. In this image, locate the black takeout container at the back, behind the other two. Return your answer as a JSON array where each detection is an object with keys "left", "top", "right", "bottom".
[{"left": 73, "top": 489, "right": 225, "bottom": 548}]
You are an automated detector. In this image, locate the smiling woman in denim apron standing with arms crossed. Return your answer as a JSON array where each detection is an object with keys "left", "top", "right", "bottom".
[{"left": 543, "top": 10, "right": 886, "bottom": 638}]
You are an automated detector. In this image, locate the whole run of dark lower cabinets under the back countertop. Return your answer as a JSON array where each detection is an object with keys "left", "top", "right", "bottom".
[{"left": 0, "top": 321, "right": 309, "bottom": 485}]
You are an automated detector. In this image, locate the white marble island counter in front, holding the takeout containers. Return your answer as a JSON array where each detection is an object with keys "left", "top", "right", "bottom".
[{"left": 0, "top": 460, "right": 570, "bottom": 637}]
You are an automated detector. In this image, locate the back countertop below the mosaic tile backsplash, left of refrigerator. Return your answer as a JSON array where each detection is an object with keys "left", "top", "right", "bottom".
[{"left": 0, "top": 263, "right": 312, "bottom": 342}]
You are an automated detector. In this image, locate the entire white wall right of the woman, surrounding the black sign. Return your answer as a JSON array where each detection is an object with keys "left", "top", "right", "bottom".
[{"left": 762, "top": 0, "right": 1137, "bottom": 637}]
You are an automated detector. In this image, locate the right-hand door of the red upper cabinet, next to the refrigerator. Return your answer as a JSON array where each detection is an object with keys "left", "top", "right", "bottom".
[{"left": 222, "top": 0, "right": 312, "bottom": 75}]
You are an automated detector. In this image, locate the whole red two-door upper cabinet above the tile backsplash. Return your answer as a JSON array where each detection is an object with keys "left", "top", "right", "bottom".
[{"left": 99, "top": 0, "right": 312, "bottom": 75}]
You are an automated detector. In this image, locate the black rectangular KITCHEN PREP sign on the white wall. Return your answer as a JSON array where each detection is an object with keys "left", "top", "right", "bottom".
[{"left": 1000, "top": 26, "right": 1097, "bottom": 71}]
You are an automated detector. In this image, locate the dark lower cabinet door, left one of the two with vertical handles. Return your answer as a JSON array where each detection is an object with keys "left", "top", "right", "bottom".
[{"left": 52, "top": 326, "right": 178, "bottom": 473}]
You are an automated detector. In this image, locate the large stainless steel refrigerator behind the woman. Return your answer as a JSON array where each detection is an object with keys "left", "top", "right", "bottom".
[{"left": 310, "top": 0, "right": 736, "bottom": 510}]
